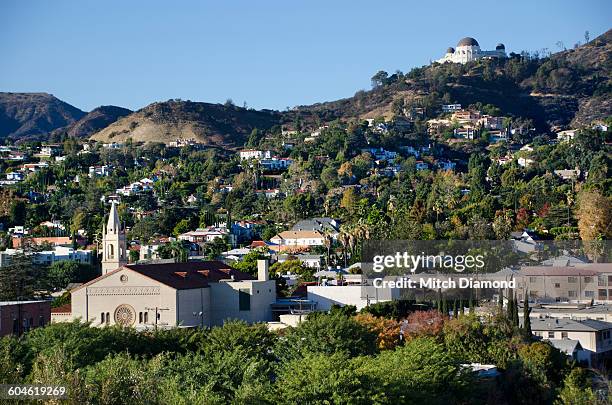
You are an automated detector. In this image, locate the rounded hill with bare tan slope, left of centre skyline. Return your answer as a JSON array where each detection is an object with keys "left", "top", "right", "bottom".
[{"left": 91, "top": 100, "right": 280, "bottom": 147}]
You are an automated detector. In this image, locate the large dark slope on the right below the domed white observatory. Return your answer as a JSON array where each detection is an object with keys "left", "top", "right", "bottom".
[{"left": 286, "top": 30, "right": 612, "bottom": 130}]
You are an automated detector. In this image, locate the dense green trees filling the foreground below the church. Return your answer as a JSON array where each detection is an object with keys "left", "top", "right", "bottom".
[{"left": 0, "top": 310, "right": 593, "bottom": 404}]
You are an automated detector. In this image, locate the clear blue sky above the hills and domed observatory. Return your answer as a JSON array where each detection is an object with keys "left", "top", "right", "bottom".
[{"left": 0, "top": 0, "right": 612, "bottom": 111}]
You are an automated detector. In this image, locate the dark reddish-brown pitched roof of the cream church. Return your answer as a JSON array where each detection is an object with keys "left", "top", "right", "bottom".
[{"left": 71, "top": 260, "right": 255, "bottom": 292}]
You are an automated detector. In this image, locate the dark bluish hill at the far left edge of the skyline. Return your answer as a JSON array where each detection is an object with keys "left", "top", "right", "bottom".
[{"left": 0, "top": 93, "right": 85, "bottom": 140}]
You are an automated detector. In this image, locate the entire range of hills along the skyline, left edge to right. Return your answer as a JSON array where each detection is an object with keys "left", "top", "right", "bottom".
[{"left": 0, "top": 30, "right": 612, "bottom": 143}]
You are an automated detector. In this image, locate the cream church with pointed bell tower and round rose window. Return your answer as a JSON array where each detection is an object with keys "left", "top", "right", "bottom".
[{"left": 52, "top": 203, "right": 276, "bottom": 329}]
